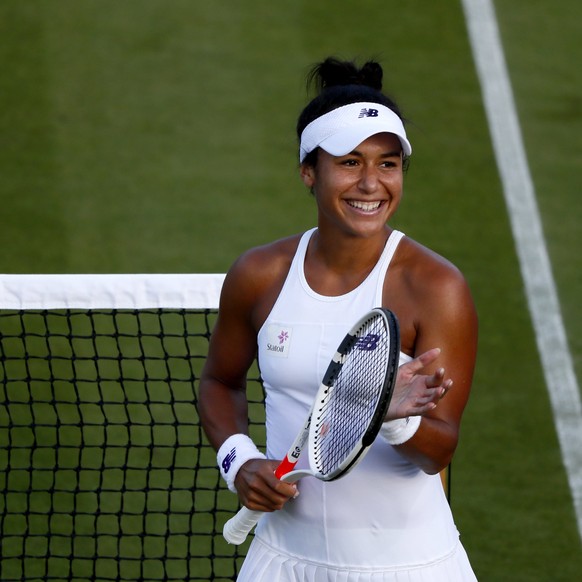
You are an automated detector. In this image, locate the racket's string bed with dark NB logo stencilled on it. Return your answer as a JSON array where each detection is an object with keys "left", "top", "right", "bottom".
[{"left": 313, "top": 317, "right": 390, "bottom": 475}]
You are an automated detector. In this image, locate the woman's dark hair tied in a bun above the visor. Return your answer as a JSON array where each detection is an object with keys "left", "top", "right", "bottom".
[{"left": 296, "top": 57, "right": 404, "bottom": 166}]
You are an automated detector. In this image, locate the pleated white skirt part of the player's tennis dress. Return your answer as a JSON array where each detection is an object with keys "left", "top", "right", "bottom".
[{"left": 237, "top": 537, "right": 477, "bottom": 582}]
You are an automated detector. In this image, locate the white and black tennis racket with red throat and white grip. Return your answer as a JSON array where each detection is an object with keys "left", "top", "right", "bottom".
[{"left": 223, "top": 307, "right": 400, "bottom": 544}]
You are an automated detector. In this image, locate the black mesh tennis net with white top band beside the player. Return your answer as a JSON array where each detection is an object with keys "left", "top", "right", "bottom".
[{"left": 0, "top": 275, "right": 264, "bottom": 582}]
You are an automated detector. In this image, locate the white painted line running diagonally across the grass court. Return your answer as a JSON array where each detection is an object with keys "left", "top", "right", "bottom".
[{"left": 462, "top": 0, "right": 582, "bottom": 538}]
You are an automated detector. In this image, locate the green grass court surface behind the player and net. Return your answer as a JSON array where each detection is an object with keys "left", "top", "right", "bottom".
[{"left": 0, "top": 0, "right": 582, "bottom": 582}]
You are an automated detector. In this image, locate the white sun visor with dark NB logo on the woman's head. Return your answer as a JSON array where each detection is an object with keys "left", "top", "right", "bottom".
[{"left": 299, "top": 103, "right": 412, "bottom": 162}]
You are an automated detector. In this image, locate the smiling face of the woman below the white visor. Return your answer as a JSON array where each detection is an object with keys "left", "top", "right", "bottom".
[{"left": 301, "top": 133, "right": 403, "bottom": 236}]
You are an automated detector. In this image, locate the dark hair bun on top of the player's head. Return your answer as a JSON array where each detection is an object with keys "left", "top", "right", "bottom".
[{"left": 308, "top": 57, "right": 383, "bottom": 92}]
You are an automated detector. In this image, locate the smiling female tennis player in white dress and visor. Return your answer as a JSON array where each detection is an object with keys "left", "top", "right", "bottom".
[{"left": 200, "top": 58, "right": 477, "bottom": 582}]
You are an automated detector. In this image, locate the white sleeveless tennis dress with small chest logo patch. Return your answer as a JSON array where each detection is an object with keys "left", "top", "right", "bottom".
[{"left": 238, "top": 229, "right": 476, "bottom": 582}]
